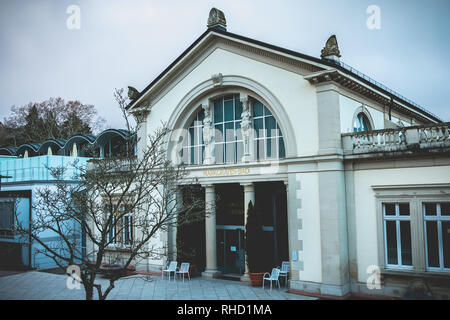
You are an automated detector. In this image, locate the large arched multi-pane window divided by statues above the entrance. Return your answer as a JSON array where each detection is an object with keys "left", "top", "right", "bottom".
[{"left": 180, "top": 93, "right": 285, "bottom": 165}]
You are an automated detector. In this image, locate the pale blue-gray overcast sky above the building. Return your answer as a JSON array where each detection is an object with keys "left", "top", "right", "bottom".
[{"left": 0, "top": 0, "right": 450, "bottom": 128}]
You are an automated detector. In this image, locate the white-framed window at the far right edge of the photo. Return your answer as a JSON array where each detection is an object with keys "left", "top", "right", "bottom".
[{"left": 422, "top": 202, "right": 450, "bottom": 272}]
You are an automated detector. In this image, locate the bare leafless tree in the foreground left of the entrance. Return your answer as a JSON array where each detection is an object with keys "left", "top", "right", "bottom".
[{"left": 13, "top": 90, "right": 205, "bottom": 300}]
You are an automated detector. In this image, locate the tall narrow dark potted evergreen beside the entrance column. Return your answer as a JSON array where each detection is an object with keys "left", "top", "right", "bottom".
[{"left": 245, "top": 201, "right": 267, "bottom": 287}]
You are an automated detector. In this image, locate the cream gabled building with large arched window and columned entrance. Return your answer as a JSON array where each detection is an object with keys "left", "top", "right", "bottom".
[{"left": 128, "top": 9, "right": 450, "bottom": 298}]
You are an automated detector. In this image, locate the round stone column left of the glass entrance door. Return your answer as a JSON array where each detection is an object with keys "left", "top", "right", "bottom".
[{"left": 202, "top": 184, "right": 220, "bottom": 278}]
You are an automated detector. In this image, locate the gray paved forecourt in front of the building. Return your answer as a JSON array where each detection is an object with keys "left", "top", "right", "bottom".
[{"left": 0, "top": 271, "right": 315, "bottom": 300}]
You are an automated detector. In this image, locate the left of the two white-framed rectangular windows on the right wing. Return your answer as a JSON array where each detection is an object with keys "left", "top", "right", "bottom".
[{"left": 383, "top": 203, "right": 412, "bottom": 269}]
